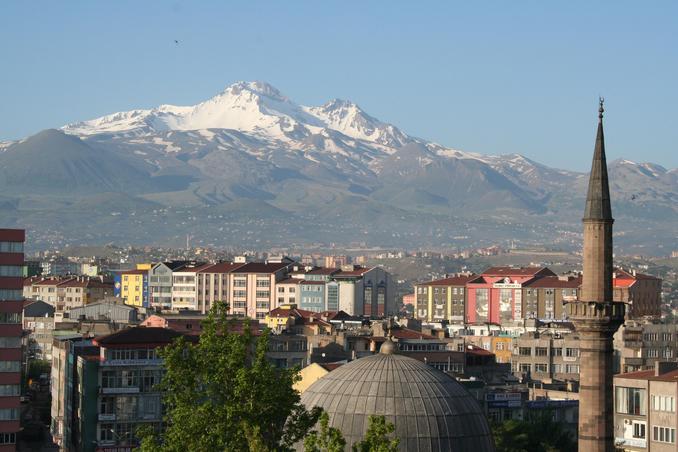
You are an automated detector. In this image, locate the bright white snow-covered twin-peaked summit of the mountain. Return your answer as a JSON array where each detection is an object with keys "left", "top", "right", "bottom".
[{"left": 62, "top": 82, "right": 411, "bottom": 146}]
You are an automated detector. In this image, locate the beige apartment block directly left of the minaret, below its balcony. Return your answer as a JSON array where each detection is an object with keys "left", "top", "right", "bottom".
[{"left": 511, "top": 332, "right": 580, "bottom": 383}]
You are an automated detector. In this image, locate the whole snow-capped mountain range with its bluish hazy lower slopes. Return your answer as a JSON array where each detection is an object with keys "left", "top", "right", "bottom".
[{"left": 0, "top": 82, "right": 678, "bottom": 251}]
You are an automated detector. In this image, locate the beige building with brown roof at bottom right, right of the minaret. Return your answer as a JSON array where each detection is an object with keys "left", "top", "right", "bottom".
[{"left": 614, "top": 361, "right": 678, "bottom": 452}]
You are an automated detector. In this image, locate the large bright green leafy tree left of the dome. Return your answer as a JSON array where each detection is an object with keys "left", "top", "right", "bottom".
[{"left": 138, "top": 302, "right": 320, "bottom": 452}]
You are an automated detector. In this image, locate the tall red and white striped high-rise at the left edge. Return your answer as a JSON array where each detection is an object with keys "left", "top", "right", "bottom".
[{"left": 0, "top": 229, "right": 25, "bottom": 451}]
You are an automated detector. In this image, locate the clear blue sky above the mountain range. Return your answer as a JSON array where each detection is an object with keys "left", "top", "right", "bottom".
[{"left": 0, "top": 0, "right": 678, "bottom": 170}]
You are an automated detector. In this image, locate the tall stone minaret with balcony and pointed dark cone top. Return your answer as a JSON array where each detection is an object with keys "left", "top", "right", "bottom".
[{"left": 568, "top": 98, "right": 624, "bottom": 452}]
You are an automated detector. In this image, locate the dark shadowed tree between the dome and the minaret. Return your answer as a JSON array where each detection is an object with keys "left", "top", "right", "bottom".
[{"left": 492, "top": 411, "right": 577, "bottom": 452}]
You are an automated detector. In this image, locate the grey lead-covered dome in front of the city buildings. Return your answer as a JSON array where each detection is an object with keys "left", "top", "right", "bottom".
[{"left": 301, "top": 353, "right": 495, "bottom": 452}]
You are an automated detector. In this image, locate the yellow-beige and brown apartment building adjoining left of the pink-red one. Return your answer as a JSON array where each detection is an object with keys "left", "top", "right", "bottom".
[{"left": 414, "top": 275, "right": 475, "bottom": 322}]
